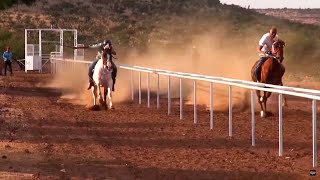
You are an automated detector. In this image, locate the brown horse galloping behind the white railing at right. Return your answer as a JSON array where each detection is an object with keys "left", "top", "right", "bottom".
[{"left": 251, "top": 40, "right": 286, "bottom": 117}]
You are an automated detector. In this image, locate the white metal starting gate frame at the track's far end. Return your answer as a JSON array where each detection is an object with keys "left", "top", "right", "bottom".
[{"left": 25, "top": 29, "right": 84, "bottom": 72}]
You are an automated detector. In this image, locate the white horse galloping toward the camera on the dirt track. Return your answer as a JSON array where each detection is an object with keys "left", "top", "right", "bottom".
[{"left": 92, "top": 58, "right": 113, "bottom": 109}]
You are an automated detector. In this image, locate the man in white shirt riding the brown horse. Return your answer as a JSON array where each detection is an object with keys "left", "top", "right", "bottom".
[{"left": 255, "top": 27, "right": 278, "bottom": 82}]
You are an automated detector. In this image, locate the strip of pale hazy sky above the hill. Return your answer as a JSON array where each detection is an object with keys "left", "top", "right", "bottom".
[{"left": 220, "top": 0, "right": 320, "bottom": 8}]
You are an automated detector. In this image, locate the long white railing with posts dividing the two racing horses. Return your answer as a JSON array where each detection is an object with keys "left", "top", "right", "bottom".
[{"left": 51, "top": 57, "right": 320, "bottom": 168}]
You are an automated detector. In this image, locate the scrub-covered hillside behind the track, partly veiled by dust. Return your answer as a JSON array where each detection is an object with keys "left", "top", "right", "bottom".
[{"left": 0, "top": 0, "right": 320, "bottom": 78}]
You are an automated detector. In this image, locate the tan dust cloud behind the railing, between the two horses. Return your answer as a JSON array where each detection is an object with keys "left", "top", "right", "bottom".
[{"left": 125, "top": 27, "right": 260, "bottom": 110}]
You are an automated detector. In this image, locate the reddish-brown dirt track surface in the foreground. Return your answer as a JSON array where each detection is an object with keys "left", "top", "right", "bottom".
[{"left": 0, "top": 72, "right": 319, "bottom": 179}]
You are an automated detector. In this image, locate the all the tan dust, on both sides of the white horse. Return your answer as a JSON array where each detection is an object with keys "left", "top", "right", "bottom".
[{"left": 48, "top": 27, "right": 260, "bottom": 110}]
